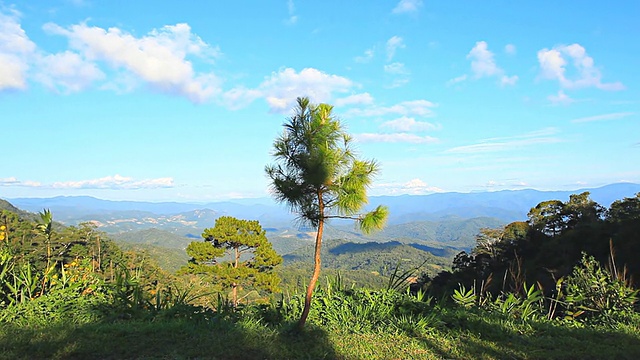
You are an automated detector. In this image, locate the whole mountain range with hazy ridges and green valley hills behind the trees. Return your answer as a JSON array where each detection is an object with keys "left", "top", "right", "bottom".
[{"left": 0, "top": 183, "right": 640, "bottom": 273}]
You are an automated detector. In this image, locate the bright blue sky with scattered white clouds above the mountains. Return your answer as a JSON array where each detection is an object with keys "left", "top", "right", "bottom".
[{"left": 0, "top": 0, "right": 640, "bottom": 202}]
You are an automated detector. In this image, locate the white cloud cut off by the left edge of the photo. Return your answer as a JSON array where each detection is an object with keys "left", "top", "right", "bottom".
[{"left": 0, "top": 11, "right": 36, "bottom": 91}]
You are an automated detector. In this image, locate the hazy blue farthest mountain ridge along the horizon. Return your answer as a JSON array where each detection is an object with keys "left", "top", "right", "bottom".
[{"left": 7, "top": 183, "right": 640, "bottom": 227}]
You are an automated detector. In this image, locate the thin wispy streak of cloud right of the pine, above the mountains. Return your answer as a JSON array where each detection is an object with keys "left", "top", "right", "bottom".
[{"left": 445, "top": 128, "right": 561, "bottom": 154}]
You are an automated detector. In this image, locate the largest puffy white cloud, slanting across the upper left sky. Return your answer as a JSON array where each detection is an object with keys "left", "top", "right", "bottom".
[{"left": 44, "top": 23, "right": 220, "bottom": 103}]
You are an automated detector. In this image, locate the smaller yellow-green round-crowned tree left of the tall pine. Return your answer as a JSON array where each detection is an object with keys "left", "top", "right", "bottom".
[{"left": 181, "top": 216, "right": 282, "bottom": 306}]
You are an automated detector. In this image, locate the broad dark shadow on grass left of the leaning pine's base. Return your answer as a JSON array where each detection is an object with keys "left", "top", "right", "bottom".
[{"left": 0, "top": 320, "right": 337, "bottom": 360}]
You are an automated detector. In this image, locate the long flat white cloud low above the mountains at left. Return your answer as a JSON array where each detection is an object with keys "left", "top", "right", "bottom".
[{"left": 51, "top": 175, "right": 174, "bottom": 190}]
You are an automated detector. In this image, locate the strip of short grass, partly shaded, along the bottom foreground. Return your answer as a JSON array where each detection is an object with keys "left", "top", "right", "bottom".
[{"left": 0, "top": 308, "right": 640, "bottom": 359}]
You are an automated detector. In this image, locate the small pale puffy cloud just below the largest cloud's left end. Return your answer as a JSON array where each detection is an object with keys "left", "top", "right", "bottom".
[{"left": 35, "top": 51, "right": 105, "bottom": 92}]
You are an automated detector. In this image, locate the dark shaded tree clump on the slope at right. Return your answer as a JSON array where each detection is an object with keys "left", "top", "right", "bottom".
[{"left": 420, "top": 192, "right": 640, "bottom": 304}]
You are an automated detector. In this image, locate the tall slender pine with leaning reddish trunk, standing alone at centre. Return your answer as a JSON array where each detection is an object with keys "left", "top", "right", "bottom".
[{"left": 265, "top": 98, "right": 388, "bottom": 329}]
